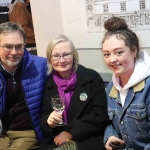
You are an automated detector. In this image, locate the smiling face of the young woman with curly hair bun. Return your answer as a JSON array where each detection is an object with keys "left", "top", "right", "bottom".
[{"left": 103, "top": 36, "right": 137, "bottom": 79}]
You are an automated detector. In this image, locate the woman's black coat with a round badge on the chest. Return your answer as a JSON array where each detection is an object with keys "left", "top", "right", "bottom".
[{"left": 40, "top": 65, "right": 109, "bottom": 150}]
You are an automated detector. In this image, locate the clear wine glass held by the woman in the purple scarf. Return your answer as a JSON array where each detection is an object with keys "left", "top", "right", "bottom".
[{"left": 51, "top": 95, "right": 66, "bottom": 126}]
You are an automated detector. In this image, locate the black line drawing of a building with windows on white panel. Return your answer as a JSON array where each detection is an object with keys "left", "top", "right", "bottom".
[{"left": 85, "top": 0, "right": 150, "bottom": 33}]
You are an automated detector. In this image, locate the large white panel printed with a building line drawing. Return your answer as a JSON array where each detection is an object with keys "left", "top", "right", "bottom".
[{"left": 60, "top": 0, "right": 150, "bottom": 49}]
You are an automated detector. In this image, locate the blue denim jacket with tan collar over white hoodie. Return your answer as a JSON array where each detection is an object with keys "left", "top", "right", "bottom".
[{"left": 104, "top": 77, "right": 150, "bottom": 150}]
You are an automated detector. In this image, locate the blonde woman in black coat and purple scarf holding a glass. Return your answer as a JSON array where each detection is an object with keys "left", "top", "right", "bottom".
[{"left": 40, "top": 35, "right": 109, "bottom": 150}]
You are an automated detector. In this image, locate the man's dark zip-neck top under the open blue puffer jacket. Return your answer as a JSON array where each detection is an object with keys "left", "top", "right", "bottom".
[{"left": 0, "top": 63, "right": 33, "bottom": 130}]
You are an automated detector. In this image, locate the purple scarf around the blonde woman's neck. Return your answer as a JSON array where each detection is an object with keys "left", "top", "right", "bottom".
[{"left": 52, "top": 71, "right": 77, "bottom": 124}]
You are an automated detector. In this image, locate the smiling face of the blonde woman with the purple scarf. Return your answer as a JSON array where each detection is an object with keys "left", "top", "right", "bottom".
[{"left": 51, "top": 41, "right": 73, "bottom": 79}]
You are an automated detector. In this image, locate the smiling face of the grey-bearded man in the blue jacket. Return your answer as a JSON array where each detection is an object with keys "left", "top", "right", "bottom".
[{"left": 0, "top": 32, "right": 24, "bottom": 72}]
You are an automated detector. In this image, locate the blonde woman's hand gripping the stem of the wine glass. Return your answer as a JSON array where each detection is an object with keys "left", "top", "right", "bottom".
[{"left": 47, "top": 111, "right": 63, "bottom": 128}]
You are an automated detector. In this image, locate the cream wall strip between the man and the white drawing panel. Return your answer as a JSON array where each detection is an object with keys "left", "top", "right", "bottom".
[{"left": 30, "top": 0, "right": 64, "bottom": 57}]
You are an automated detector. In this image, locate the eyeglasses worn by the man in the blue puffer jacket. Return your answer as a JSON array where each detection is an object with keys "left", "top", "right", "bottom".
[{"left": 0, "top": 44, "right": 25, "bottom": 52}]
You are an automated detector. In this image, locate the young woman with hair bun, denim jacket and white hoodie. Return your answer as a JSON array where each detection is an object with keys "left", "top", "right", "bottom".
[{"left": 102, "top": 17, "right": 150, "bottom": 150}]
